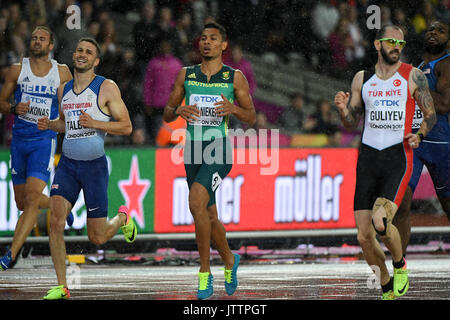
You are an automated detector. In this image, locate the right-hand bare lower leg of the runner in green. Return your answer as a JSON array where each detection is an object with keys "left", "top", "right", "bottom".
[{"left": 208, "top": 204, "right": 234, "bottom": 269}]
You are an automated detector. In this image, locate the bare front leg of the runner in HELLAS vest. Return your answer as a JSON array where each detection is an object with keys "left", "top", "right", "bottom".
[{"left": 11, "top": 177, "right": 47, "bottom": 260}]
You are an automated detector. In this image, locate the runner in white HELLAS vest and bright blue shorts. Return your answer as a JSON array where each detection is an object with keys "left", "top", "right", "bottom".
[{"left": 0, "top": 26, "right": 72, "bottom": 270}]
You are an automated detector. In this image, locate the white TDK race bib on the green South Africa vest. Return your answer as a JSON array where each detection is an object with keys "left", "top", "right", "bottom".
[{"left": 189, "top": 94, "right": 223, "bottom": 127}]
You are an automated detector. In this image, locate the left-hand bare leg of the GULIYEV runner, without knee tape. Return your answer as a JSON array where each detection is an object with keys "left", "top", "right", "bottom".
[{"left": 355, "top": 210, "right": 390, "bottom": 285}]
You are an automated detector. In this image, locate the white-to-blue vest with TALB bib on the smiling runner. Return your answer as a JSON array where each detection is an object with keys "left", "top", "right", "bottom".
[{"left": 61, "top": 75, "right": 111, "bottom": 161}]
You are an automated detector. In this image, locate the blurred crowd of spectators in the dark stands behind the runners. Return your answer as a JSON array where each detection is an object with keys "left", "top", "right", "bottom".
[{"left": 0, "top": 0, "right": 450, "bottom": 146}]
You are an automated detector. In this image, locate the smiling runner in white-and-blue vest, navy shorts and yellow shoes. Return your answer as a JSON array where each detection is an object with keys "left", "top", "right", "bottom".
[{"left": 38, "top": 38, "right": 137, "bottom": 300}]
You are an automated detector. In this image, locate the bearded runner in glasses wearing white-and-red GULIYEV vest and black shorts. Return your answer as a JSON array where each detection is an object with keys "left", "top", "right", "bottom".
[{"left": 334, "top": 25, "right": 436, "bottom": 300}]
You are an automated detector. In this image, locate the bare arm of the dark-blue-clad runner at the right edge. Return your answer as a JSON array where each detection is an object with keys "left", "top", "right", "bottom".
[{"left": 430, "top": 58, "right": 450, "bottom": 114}]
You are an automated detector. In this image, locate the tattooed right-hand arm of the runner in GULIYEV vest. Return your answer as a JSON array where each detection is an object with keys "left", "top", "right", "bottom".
[{"left": 410, "top": 68, "right": 436, "bottom": 136}]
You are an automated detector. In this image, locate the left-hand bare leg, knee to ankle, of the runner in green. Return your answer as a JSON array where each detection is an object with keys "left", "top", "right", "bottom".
[{"left": 189, "top": 182, "right": 211, "bottom": 273}]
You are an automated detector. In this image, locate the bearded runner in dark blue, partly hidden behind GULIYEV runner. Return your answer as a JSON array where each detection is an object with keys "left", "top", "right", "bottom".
[{"left": 393, "top": 21, "right": 450, "bottom": 255}]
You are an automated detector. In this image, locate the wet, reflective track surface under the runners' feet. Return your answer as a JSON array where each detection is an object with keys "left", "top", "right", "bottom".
[{"left": 0, "top": 244, "right": 450, "bottom": 300}]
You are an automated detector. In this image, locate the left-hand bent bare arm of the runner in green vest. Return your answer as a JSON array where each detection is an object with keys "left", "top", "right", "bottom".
[{"left": 163, "top": 68, "right": 200, "bottom": 122}]
